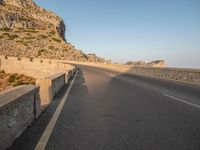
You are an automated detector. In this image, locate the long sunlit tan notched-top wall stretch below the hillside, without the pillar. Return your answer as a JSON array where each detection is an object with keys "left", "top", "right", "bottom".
[{"left": 0, "top": 56, "right": 72, "bottom": 78}]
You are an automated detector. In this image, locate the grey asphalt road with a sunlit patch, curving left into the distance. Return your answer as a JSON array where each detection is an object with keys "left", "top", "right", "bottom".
[{"left": 11, "top": 66, "right": 200, "bottom": 150}]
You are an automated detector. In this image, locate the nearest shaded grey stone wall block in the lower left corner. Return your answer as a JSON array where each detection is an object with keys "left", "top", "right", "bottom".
[{"left": 0, "top": 85, "right": 41, "bottom": 150}]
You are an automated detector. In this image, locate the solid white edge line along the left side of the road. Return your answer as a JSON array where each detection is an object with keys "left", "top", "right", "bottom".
[{"left": 35, "top": 73, "right": 77, "bottom": 150}]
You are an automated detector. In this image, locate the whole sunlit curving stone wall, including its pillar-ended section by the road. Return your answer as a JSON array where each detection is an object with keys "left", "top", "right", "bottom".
[{"left": 0, "top": 56, "right": 75, "bottom": 107}]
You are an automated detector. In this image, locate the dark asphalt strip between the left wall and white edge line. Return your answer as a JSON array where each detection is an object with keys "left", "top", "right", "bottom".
[{"left": 9, "top": 74, "right": 78, "bottom": 150}]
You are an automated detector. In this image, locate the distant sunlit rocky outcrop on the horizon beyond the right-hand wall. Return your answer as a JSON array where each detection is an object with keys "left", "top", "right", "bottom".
[{"left": 126, "top": 60, "right": 166, "bottom": 68}]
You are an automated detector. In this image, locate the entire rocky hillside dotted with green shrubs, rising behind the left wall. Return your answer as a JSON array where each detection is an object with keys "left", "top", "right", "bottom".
[{"left": 0, "top": 0, "right": 108, "bottom": 62}]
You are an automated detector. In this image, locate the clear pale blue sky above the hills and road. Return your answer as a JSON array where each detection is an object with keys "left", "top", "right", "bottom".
[{"left": 35, "top": 0, "right": 200, "bottom": 68}]
